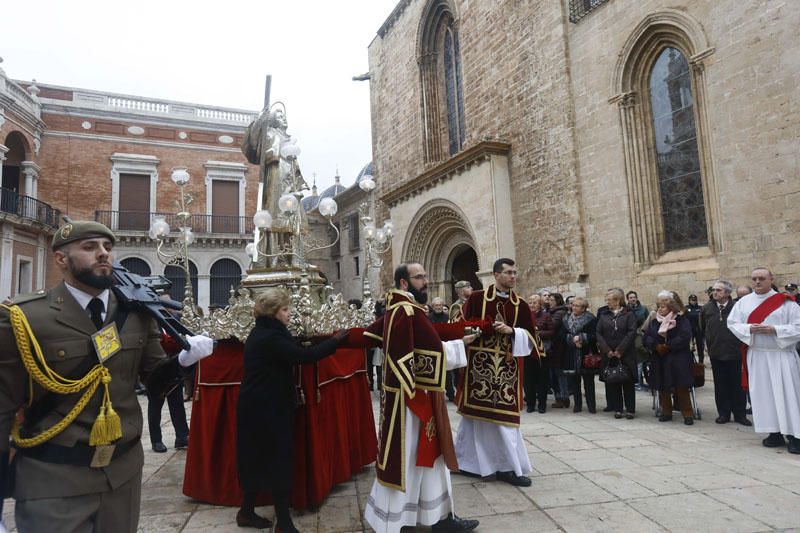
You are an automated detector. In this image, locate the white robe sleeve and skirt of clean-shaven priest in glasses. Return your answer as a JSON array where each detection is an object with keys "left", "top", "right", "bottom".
[{"left": 455, "top": 328, "right": 533, "bottom": 476}]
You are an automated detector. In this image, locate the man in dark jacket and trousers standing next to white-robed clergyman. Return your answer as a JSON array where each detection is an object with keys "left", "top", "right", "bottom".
[{"left": 700, "top": 280, "right": 753, "bottom": 426}]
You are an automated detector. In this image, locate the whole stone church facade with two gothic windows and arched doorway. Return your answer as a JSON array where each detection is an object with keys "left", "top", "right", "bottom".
[{"left": 369, "top": 0, "right": 800, "bottom": 307}]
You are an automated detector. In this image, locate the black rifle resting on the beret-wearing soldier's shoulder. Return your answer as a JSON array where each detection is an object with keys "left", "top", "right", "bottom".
[{"left": 111, "top": 261, "right": 194, "bottom": 350}]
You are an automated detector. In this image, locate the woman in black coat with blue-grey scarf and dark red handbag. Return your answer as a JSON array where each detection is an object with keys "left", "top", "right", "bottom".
[{"left": 564, "top": 296, "right": 601, "bottom": 414}]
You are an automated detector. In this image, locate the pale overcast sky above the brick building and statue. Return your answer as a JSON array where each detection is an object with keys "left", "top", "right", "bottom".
[{"left": 0, "top": 0, "right": 398, "bottom": 195}]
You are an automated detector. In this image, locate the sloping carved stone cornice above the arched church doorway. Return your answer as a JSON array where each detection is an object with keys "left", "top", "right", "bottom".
[{"left": 381, "top": 141, "right": 511, "bottom": 207}]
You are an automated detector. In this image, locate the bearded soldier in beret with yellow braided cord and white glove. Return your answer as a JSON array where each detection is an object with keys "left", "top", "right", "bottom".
[{"left": 0, "top": 221, "right": 213, "bottom": 533}]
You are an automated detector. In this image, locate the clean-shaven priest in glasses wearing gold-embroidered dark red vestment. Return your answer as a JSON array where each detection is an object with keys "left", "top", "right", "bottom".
[{"left": 456, "top": 258, "right": 541, "bottom": 487}]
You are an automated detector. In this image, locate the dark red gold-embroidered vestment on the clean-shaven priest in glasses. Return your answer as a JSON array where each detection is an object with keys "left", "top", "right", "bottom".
[{"left": 456, "top": 285, "right": 541, "bottom": 426}]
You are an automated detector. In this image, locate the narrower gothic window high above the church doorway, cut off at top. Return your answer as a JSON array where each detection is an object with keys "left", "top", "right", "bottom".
[{"left": 419, "top": 0, "right": 466, "bottom": 162}]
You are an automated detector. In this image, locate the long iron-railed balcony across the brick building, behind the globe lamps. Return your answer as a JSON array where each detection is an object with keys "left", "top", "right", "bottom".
[{"left": 94, "top": 211, "right": 254, "bottom": 237}]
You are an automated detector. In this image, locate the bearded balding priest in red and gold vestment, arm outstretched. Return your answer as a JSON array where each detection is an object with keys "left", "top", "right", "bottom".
[{"left": 364, "top": 263, "right": 478, "bottom": 533}]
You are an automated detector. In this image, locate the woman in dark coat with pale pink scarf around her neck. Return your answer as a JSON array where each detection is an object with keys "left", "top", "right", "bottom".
[{"left": 644, "top": 291, "right": 694, "bottom": 426}]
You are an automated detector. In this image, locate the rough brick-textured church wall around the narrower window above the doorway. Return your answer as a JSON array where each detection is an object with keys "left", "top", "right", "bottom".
[{"left": 369, "top": 0, "right": 584, "bottom": 294}]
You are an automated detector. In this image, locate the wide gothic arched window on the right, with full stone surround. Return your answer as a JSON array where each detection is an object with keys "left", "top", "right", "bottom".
[{"left": 609, "top": 10, "right": 720, "bottom": 268}]
